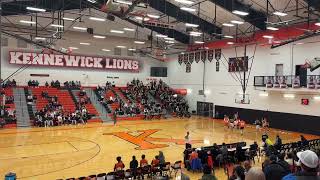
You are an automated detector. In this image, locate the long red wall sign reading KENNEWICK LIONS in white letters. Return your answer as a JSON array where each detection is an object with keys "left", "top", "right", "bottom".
[{"left": 8, "top": 51, "right": 140, "bottom": 72}]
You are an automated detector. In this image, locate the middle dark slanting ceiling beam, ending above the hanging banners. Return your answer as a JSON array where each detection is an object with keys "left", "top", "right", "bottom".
[{"left": 148, "top": 0, "right": 221, "bottom": 35}]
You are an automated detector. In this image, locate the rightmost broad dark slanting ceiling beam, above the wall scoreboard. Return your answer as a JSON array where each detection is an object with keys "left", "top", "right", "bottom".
[{"left": 209, "top": 0, "right": 267, "bottom": 30}]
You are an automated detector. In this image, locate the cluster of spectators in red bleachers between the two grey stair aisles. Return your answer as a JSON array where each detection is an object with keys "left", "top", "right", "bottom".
[{"left": 34, "top": 96, "right": 91, "bottom": 127}]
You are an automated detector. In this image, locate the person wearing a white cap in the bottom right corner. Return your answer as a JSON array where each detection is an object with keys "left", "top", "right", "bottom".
[{"left": 282, "top": 150, "right": 319, "bottom": 180}]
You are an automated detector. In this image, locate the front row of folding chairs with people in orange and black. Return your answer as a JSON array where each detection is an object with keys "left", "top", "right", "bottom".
[{"left": 60, "top": 151, "right": 181, "bottom": 180}]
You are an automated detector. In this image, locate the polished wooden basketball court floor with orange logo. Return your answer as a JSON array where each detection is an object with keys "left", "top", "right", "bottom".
[{"left": 0, "top": 117, "right": 316, "bottom": 180}]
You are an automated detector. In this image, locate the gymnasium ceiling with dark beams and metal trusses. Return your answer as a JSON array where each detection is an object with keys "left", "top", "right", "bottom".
[{"left": 1, "top": 0, "right": 320, "bottom": 54}]
